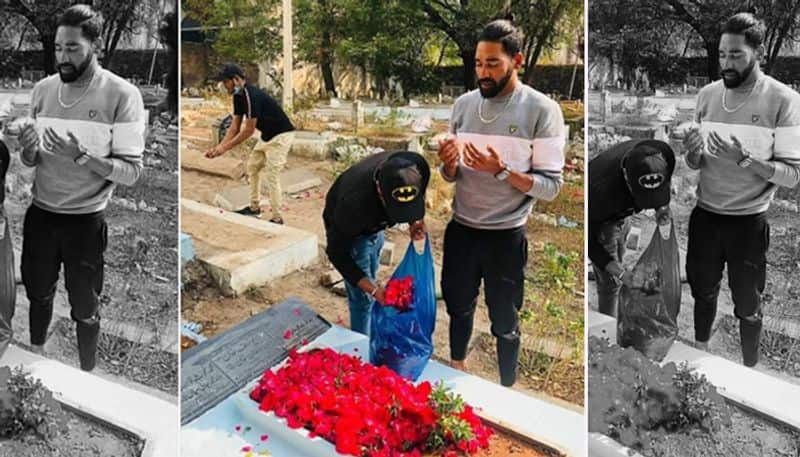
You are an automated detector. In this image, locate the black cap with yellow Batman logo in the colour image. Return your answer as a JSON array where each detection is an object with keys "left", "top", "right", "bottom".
[{"left": 378, "top": 151, "right": 431, "bottom": 223}]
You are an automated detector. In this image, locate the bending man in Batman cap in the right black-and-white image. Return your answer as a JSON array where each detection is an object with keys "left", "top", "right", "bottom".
[{"left": 588, "top": 140, "right": 675, "bottom": 317}]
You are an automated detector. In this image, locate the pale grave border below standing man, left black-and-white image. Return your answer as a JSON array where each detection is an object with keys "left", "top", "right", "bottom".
[{"left": 0, "top": 345, "right": 179, "bottom": 457}]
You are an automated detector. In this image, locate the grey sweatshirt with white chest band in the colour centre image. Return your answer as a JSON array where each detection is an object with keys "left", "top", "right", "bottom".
[{"left": 442, "top": 82, "right": 566, "bottom": 230}]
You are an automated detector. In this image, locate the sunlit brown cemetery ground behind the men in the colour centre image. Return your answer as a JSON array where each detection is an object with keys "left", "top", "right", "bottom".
[{"left": 181, "top": 95, "right": 584, "bottom": 408}]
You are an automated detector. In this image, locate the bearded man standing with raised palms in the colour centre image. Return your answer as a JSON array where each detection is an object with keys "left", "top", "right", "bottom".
[{"left": 439, "top": 20, "right": 566, "bottom": 386}]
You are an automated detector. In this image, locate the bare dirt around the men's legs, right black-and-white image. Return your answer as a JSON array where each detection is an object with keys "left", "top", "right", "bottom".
[{"left": 588, "top": 91, "right": 800, "bottom": 383}]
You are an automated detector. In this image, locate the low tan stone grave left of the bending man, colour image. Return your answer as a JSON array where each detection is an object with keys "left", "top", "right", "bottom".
[{"left": 181, "top": 199, "right": 318, "bottom": 295}]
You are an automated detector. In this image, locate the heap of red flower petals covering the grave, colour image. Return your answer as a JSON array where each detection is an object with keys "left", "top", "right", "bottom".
[{"left": 250, "top": 349, "right": 491, "bottom": 457}]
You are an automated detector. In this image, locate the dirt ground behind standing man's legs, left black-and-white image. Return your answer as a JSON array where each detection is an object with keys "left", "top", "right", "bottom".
[{"left": 5, "top": 107, "right": 178, "bottom": 398}]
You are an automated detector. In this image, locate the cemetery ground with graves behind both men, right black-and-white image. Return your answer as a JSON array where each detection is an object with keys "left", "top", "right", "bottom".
[{"left": 588, "top": 89, "right": 800, "bottom": 384}]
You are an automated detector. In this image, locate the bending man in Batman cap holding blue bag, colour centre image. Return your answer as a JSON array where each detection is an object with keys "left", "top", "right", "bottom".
[{"left": 322, "top": 151, "right": 430, "bottom": 335}]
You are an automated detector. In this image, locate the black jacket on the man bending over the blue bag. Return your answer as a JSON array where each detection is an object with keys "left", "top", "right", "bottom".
[{"left": 322, "top": 151, "right": 394, "bottom": 284}]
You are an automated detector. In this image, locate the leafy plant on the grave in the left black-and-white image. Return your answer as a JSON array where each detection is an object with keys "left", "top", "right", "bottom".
[{"left": 0, "top": 366, "right": 66, "bottom": 440}]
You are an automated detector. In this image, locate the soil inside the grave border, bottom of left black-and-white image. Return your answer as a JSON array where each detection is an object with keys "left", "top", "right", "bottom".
[{"left": 0, "top": 411, "right": 143, "bottom": 457}]
